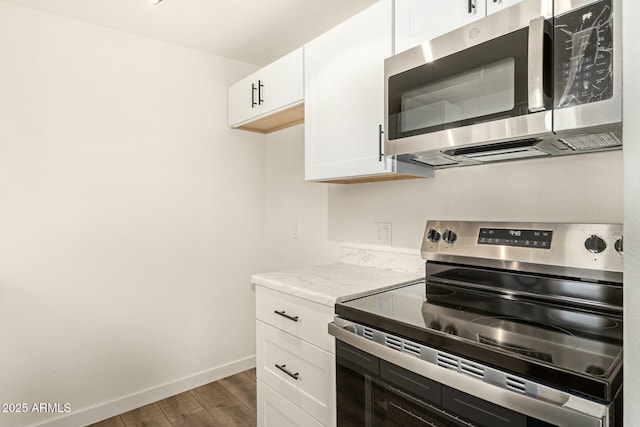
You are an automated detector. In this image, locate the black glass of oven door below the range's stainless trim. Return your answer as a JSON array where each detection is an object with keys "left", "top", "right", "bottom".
[{"left": 336, "top": 340, "right": 536, "bottom": 427}]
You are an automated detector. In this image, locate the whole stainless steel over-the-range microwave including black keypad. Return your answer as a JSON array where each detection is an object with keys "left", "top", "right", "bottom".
[{"left": 385, "top": 0, "right": 622, "bottom": 168}]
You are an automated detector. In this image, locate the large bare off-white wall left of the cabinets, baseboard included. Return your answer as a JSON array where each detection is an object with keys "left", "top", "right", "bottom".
[{"left": 0, "top": 3, "right": 266, "bottom": 427}]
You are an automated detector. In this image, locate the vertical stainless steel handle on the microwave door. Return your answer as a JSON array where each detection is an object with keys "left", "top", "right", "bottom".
[{"left": 527, "top": 16, "right": 545, "bottom": 113}]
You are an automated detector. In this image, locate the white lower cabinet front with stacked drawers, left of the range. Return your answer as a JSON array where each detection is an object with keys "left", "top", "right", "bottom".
[{"left": 256, "top": 286, "right": 336, "bottom": 427}]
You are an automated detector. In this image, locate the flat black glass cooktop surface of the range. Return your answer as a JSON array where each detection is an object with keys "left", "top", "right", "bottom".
[{"left": 336, "top": 282, "right": 622, "bottom": 400}]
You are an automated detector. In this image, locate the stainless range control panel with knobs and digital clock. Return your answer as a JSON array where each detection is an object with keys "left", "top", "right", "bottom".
[{"left": 421, "top": 220, "right": 623, "bottom": 278}]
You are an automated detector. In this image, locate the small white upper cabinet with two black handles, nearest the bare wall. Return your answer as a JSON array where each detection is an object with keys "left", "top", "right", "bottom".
[{"left": 229, "top": 48, "right": 304, "bottom": 133}]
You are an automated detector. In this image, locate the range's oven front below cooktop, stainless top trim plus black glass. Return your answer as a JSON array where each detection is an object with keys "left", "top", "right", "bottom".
[{"left": 329, "top": 319, "right": 621, "bottom": 427}]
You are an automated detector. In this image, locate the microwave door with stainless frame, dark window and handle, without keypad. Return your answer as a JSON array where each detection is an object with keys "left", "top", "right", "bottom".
[{"left": 385, "top": 0, "right": 553, "bottom": 160}]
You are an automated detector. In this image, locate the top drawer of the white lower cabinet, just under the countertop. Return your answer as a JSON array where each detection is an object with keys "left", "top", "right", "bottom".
[{"left": 256, "top": 286, "right": 335, "bottom": 353}]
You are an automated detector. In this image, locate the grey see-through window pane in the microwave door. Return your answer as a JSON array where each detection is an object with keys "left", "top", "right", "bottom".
[{"left": 398, "top": 57, "right": 515, "bottom": 132}]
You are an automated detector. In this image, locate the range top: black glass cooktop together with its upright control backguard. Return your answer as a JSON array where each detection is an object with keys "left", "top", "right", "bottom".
[{"left": 336, "top": 221, "right": 623, "bottom": 401}]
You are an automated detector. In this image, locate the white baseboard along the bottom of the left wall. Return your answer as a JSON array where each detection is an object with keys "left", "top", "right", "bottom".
[{"left": 31, "top": 356, "right": 256, "bottom": 427}]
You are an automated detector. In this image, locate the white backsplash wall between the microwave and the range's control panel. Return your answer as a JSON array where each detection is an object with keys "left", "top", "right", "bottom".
[{"left": 329, "top": 151, "right": 623, "bottom": 249}]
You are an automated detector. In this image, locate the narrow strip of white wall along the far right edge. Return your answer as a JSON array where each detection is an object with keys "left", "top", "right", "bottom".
[{"left": 622, "top": 0, "right": 640, "bottom": 426}]
